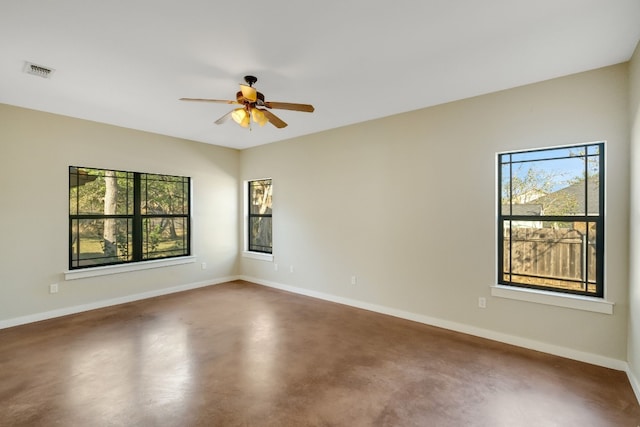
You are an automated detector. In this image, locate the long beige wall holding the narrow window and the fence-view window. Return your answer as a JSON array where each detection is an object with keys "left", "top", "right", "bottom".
[{"left": 241, "top": 64, "right": 629, "bottom": 360}]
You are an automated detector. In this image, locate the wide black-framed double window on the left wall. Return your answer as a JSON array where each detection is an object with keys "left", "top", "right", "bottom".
[{"left": 69, "top": 166, "right": 191, "bottom": 269}]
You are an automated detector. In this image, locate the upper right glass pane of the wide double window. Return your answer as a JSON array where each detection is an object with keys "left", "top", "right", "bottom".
[{"left": 140, "top": 174, "right": 189, "bottom": 215}]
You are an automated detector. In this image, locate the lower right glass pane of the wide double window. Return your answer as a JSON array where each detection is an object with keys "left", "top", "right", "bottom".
[{"left": 142, "top": 217, "right": 188, "bottom": 259}]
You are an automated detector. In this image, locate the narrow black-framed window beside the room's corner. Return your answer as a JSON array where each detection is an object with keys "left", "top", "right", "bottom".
[{"left": 247, "top": 179, "right": 273, "bottom": 254}]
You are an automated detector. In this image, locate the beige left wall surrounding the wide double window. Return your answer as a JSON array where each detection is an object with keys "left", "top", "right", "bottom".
[{"left": 0, "top": 104, "right": 239, "bottom": 324}]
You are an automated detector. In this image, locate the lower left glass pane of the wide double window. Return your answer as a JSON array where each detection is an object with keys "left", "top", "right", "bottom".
[{"left": 71, "top": 218, "right": 132, "bottom": 267}]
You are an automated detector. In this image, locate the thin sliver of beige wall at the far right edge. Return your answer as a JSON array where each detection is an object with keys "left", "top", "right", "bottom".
[{"left": 628, "top": 44, "right": 640, "bottom": 382}]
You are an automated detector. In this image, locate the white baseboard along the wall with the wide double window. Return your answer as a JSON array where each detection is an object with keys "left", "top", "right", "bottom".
[{"left": 0, "top": 276, "right": 239, "bottom": 329}]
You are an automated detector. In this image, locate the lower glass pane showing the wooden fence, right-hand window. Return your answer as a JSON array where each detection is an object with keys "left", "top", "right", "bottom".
[{"left": 502, "top": 220, "right": 597, "bottom": 292}]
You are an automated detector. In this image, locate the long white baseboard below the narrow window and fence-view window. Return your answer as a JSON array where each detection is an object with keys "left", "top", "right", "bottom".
[{"left": 239, "top": 276, "right": 628, "bottom": 372}]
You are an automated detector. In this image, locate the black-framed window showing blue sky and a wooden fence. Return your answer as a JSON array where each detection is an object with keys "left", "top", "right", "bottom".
[{"left": 498, "top": 143, "right": 604, "bottom": 297}]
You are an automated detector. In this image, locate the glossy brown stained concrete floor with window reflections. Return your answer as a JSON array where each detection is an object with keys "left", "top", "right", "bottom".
[{"left": 0, "top": 281, "right": 640, "bottom": 427}]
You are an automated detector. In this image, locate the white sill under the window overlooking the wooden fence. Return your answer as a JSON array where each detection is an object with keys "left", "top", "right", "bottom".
[{"left": 491, "top": 285, "right": 614, "bottom": 314}]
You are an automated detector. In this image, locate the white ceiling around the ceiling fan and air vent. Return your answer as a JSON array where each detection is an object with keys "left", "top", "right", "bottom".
[{"left": 0, "top": 0, "right": 640, "bottom": 149}]
